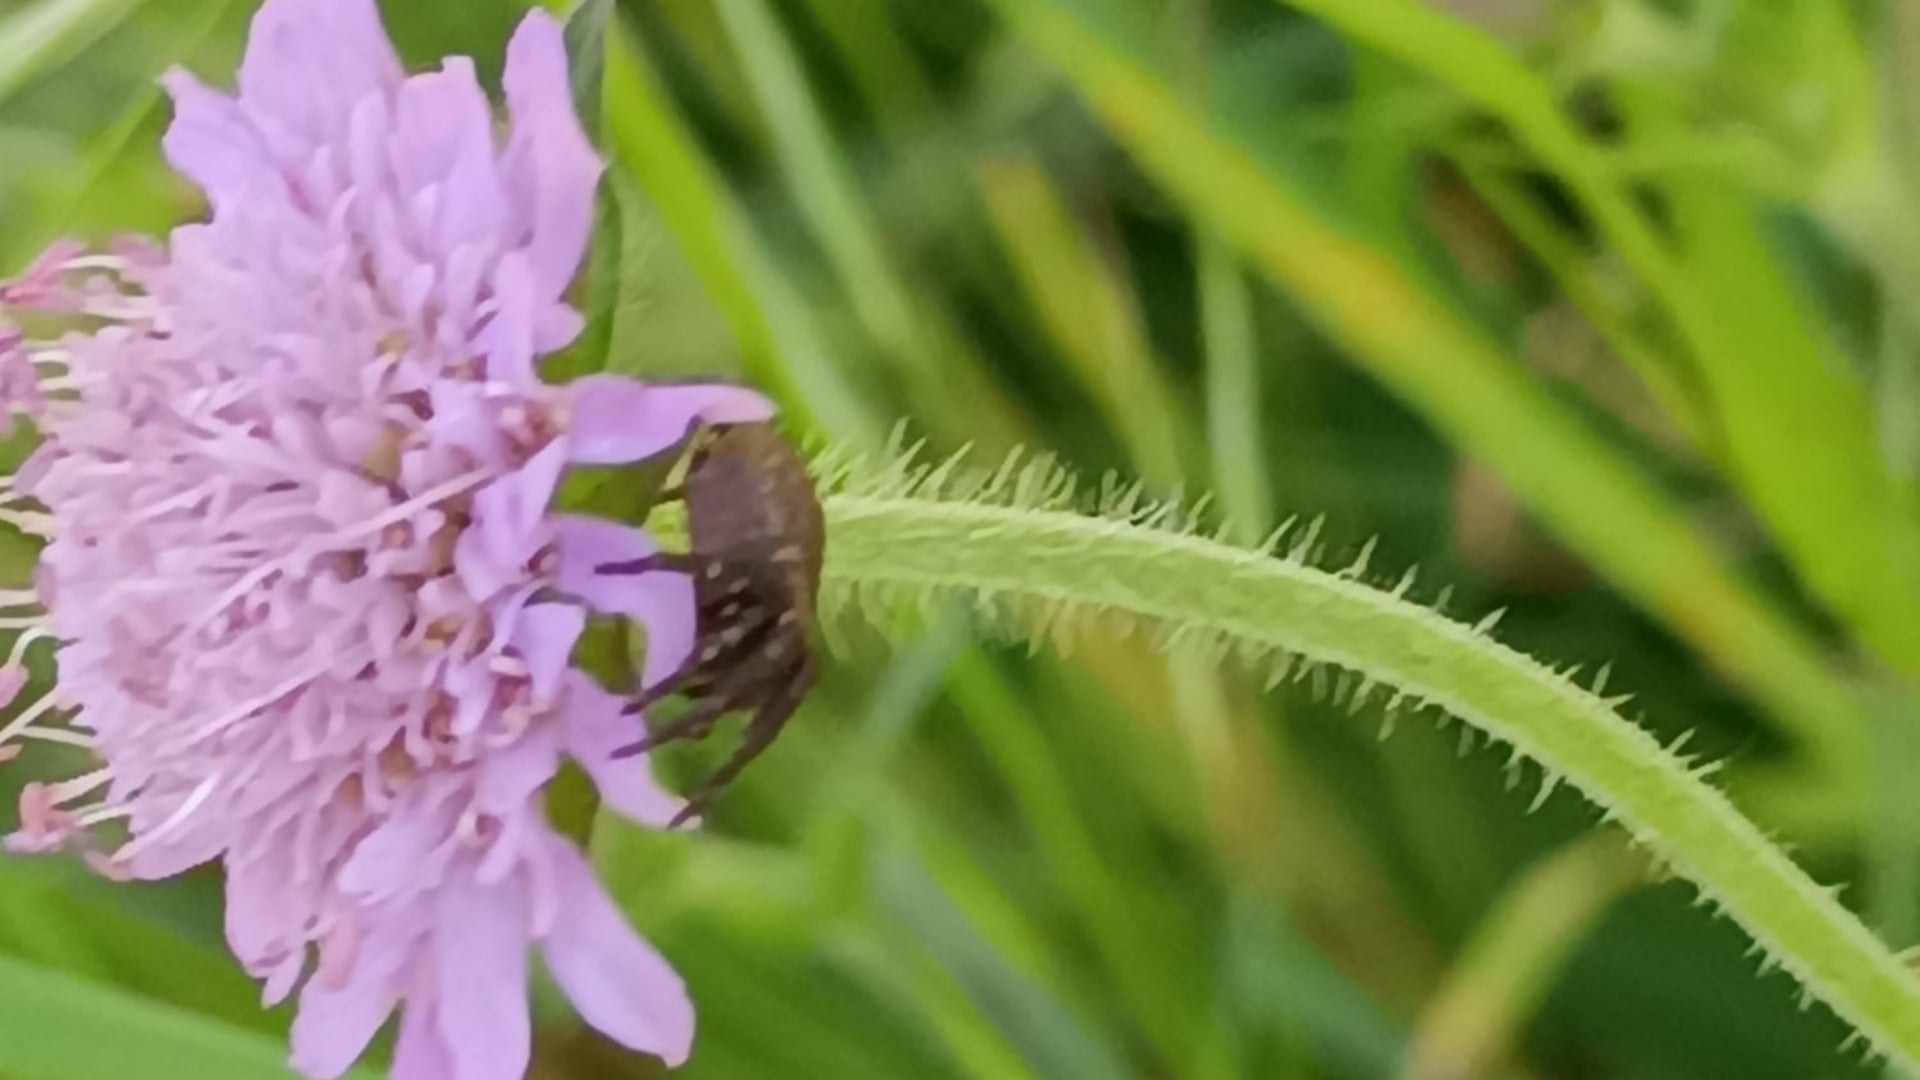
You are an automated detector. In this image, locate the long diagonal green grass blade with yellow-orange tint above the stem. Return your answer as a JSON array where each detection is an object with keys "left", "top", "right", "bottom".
[{"left": 996, "top": 0, "right": 1866, "bottom": 813}]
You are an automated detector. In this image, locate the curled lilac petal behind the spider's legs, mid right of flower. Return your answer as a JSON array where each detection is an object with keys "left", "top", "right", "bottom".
[{"left": 553, "top": 513, "right": 697, "bottom": 686}]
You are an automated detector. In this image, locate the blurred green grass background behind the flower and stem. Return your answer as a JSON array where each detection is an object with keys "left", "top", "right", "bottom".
[{"left": 11, "top": 0, "right": 1920, "bottom": 1080}]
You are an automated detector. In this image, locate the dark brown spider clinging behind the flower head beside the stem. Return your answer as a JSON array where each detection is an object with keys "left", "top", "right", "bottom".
[{"left": 597, "top": 423, "right": 826, "bottom": 828}]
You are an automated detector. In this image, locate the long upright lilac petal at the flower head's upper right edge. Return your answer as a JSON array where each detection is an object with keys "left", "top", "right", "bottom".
[{"left": 503, "top": 12, "right": 601, "bottom": 302}]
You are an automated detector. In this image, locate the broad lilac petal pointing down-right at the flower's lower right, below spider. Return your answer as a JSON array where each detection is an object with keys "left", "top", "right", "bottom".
[{"left": 545, "top": 840, "right": 693, "bottom": 1067}]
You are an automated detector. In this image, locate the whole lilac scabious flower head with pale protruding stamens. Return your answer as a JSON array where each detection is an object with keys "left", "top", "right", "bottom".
[{"left": 0, "top": 0, "right": 770, "bottom": 1080}]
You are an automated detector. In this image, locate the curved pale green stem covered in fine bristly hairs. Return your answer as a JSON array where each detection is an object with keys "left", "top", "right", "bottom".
[{"left": 802, "top": 491, "right": 1920, "bottom": 1065}]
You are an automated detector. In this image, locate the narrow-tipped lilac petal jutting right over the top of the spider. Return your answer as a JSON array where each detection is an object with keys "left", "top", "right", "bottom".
[{"left": 568, "top": 375, "right": 774, "bottom": 465}]
